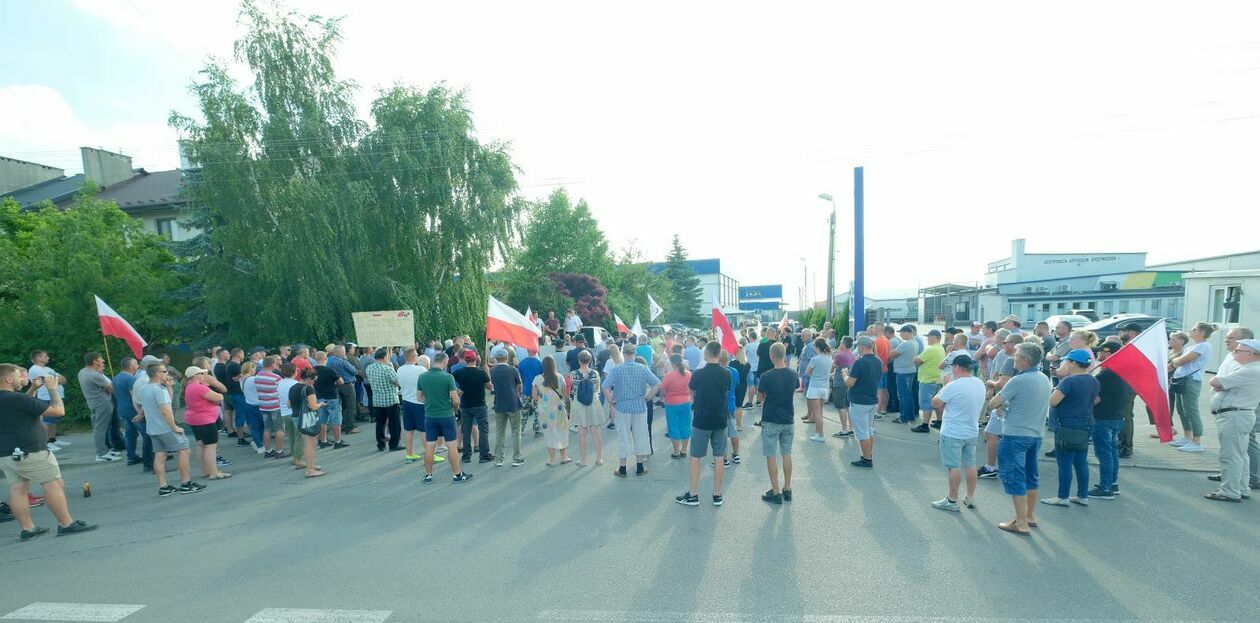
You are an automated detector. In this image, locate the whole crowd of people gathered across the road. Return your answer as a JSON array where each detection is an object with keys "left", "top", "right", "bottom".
[{"left": 0, "top": 310, "right": 1260, "bottom": 540}]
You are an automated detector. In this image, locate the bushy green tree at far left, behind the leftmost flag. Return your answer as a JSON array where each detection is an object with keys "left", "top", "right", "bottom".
[{"left": 0, "top": 190, "right": 184, "bottom": 421}]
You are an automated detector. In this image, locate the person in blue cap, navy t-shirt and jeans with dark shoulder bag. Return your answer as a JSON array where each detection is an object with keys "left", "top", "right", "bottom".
[{"left": 1041, "top": 349, "right": 1099, "bottom": 506}]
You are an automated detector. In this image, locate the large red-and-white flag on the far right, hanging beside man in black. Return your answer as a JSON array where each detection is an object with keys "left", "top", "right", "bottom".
[{"left": 1099, "top": 320, "right": 1173, "bottom": 444}]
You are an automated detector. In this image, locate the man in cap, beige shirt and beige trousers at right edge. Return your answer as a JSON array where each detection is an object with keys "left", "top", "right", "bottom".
[{"left": 1203, "top": 338, "right": 1260, "bottom": 502}]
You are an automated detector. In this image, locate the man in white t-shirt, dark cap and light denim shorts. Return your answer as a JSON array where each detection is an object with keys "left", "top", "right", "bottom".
[{"left": 932, "top": 354, "right": 985, "bottom": 511}]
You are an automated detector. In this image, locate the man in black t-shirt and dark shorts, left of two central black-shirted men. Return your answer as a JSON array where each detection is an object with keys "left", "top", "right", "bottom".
[{"left": 674, "top": 342, "right": 731, "bottom": 506}]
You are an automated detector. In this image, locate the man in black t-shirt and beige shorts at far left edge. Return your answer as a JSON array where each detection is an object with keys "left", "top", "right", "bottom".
[{"left": 0, "top": 363, "right": 96, "bottom": 541}]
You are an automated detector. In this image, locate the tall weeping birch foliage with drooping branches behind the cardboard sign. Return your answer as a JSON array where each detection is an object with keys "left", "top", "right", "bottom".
[{"left": 171, "top": 0, "right": 519, "bottom": 343}]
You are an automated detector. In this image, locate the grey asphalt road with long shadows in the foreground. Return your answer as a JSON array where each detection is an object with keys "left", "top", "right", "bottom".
[{"left": 0, "top": 395, "right": 1260, "bottom": 623}]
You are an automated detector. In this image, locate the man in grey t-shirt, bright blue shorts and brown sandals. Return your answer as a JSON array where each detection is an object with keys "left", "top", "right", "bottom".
[{"left": 989, "top": 343, "right": 1051, "bottom": 536}]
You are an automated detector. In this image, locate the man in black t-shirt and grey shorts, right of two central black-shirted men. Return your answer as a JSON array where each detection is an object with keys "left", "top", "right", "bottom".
[{"left": 757, "top": 343, "right": 800, "bottom": 504}]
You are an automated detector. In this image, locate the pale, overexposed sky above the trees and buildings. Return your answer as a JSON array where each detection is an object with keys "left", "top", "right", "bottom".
[{"left": 0, "top": 0, "right": 1260, "bottom": 305}]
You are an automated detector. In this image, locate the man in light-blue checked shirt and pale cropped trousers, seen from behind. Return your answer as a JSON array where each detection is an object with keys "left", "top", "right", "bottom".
[{"left": 604, "top": 343, "right": 660, "bottom": 478}]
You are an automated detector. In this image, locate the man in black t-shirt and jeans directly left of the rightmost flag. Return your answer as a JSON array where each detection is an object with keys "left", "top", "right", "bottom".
[{"left": 1088, "top": 341, "right": 1135, "bottom": 499}]
